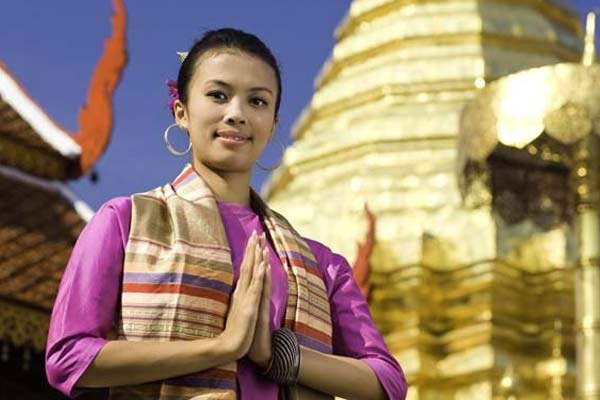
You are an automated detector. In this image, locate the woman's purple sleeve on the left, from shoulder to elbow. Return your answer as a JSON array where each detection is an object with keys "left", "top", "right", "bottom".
[{"left": 46, "top": 198, "right": 131, "bottom": 397}]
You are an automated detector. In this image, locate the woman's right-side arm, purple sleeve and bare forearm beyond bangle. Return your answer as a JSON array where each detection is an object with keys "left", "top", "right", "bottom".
[{"left": 299, "top": 240, "right": 406, "bottom": 399}]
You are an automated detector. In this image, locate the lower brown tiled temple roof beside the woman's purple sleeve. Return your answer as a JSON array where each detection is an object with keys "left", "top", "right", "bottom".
[{"left": 0, "top": 166, "right": 93, "bottom": 350}]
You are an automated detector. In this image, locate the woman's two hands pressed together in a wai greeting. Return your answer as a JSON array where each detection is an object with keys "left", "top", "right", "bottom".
[{"left": 221, "top": 232, "right": 271, "bottom": 368}]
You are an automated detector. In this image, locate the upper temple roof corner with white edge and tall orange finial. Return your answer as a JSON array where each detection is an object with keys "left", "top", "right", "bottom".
[{"left": 0, "top": 0, "right": 127, "bottom": 180}]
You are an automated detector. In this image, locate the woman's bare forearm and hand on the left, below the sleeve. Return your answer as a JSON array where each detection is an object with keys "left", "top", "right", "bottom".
[{"left": 77, "top": 230, "right": 266, "bottom": 387}]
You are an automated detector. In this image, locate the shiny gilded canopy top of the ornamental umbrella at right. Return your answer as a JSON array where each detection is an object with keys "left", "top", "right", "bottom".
[{"left": 458, "top": 63, "right": 600, "bottom": 168}]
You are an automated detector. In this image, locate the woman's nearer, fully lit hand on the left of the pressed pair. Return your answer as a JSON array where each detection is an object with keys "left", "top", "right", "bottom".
[{"left": 220, "top": 232, "right": 266, "bottom": 360}]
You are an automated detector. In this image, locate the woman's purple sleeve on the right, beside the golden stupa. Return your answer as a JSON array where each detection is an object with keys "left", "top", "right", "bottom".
[{"left": 308, "top": 241, "right": 407, "bottom": 400}]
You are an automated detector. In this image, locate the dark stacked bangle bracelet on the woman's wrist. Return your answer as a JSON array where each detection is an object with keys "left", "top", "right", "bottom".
[{"left": 263, "top": 328, "right": 300, "bottom": 385}]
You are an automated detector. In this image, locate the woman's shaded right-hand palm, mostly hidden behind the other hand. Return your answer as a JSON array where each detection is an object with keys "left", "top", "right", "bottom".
[{"left": 248, "top": 234, "right": 272, "bottom": 369}]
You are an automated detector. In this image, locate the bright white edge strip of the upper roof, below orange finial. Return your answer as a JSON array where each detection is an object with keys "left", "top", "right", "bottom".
[{"left": 0, "top": 66, "right": 81, "bottom": 158}]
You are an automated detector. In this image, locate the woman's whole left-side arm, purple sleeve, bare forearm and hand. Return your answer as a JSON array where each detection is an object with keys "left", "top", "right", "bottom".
[{"left": 46, "top": 199, "right": 263, "bottom": 396}]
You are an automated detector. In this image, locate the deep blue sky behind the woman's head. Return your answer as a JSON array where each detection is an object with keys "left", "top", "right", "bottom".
[{"left": 0, "top": 0, "right": 600, "bottom": 208}]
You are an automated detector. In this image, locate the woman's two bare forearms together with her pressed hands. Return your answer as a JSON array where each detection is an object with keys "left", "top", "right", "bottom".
[{"left": 76, "top": 233, "right": 394, "bottom": 399}]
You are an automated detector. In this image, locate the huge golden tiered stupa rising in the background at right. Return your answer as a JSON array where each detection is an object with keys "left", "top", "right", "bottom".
[{"left": 265, "top": 0, "right": 600, "bottom": 400}]
